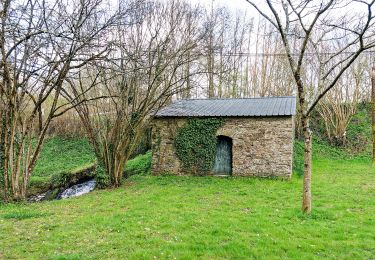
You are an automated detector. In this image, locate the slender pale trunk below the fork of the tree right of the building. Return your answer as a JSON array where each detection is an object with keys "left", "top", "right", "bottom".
[{"left": 302, "top": 116, "right": 312, "bottom": 214}]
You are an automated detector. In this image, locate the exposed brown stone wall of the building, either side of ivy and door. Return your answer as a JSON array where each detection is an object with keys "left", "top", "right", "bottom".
[{"left": 152, "top": 116, "right": 294, "bottom": 178}]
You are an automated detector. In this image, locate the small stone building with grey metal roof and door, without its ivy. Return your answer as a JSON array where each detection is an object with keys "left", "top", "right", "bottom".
[{"left": 152, "top": 97, "right": 296, "bottom": 178}]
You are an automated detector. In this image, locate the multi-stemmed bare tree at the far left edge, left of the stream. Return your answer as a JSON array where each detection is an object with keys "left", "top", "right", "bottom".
[{"left": 0, "top": 0, "right": 119, "bottom": 200}]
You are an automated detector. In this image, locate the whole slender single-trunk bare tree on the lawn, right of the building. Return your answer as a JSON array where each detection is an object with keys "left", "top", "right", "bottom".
[{"left": 246, "top": 0, "right": 375, "bottom": 213}]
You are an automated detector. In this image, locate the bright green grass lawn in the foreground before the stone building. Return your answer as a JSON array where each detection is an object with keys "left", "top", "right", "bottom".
[{"left": 0, "top": 152, "right": 375, "bottom": 259}]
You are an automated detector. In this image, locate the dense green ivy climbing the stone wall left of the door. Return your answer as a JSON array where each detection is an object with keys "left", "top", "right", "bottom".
[{"left": 175, "top": 118, "right": 224, "bottom": 175}]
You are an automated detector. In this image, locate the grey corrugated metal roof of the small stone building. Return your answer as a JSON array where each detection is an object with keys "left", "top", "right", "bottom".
[{"left": 155, "top": 97, "right": 296, "bottom": 117}]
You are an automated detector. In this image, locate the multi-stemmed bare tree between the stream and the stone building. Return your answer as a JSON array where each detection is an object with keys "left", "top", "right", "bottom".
[{"left": 64, "top": 1, "right": 206, "bottom": 187}]
